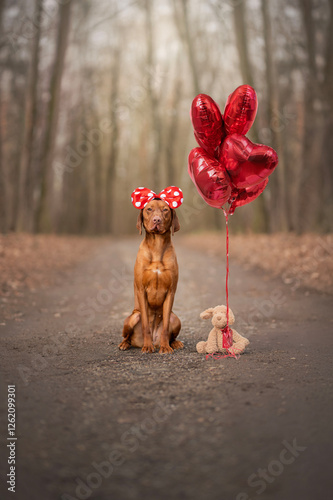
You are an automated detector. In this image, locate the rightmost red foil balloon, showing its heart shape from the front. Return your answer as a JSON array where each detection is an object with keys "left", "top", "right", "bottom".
[{"left": 219, "top": 134, "right": 278, "bottom": 189}]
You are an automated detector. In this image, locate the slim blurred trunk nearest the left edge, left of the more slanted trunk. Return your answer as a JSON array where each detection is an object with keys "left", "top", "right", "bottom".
[{"left": 17, "top": 0, "right": 43, "bottom": 230}]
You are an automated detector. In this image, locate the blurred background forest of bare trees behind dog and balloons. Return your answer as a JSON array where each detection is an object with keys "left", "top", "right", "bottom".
[{"left": 0, "top": 0, "right": 333, "bottom": 234}]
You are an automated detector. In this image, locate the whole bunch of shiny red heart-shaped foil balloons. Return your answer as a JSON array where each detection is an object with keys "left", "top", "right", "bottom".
[{"left": 188, "top": 85, "right": 278, "bottom": 213}]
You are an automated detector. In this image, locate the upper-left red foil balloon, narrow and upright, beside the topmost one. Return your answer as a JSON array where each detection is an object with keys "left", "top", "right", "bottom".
[{"left": 191, "top": 94, "right": 225, "bottom": 156}]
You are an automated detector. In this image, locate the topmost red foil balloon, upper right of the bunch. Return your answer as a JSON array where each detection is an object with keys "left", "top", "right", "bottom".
[{"left": 223, "top": 85, "right": 258, "bottom": 135}]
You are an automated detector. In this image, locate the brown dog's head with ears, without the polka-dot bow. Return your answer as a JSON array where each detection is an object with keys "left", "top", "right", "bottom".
[{"left": 136, "top": 199, "right": 180, "bottom": 234}]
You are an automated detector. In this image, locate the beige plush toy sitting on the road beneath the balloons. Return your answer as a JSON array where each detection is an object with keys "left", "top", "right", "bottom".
[{"left": 196, "top": 306, "right": 250, "bottom": 354}]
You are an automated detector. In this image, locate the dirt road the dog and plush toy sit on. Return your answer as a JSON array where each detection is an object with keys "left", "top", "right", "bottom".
[{"left": 0, "top": 235, "right": 333, "bottom": 500}]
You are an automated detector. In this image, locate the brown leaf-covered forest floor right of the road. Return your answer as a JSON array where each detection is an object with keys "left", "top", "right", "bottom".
[{"left": 180, "top": 233, "right": 333, "bottom": 294}]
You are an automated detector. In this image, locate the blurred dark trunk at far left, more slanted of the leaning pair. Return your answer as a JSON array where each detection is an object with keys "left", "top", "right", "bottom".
[{"left": 34, "top": 0, "right": 72, "bottom": 232}]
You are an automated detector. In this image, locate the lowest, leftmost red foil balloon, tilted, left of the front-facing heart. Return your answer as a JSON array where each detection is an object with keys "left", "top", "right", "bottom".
[{"left": 188, "top": 148, "right": 231, "bottom": 208}]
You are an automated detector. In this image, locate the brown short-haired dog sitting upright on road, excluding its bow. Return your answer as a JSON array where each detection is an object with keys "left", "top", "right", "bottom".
[{"left": 119, "top": 199, "right": 183, "bottom": 354}]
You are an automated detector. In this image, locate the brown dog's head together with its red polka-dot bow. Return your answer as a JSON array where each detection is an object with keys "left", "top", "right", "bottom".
[{"left": 132, "top": 186, "right": 183, "bottom": 234}]
